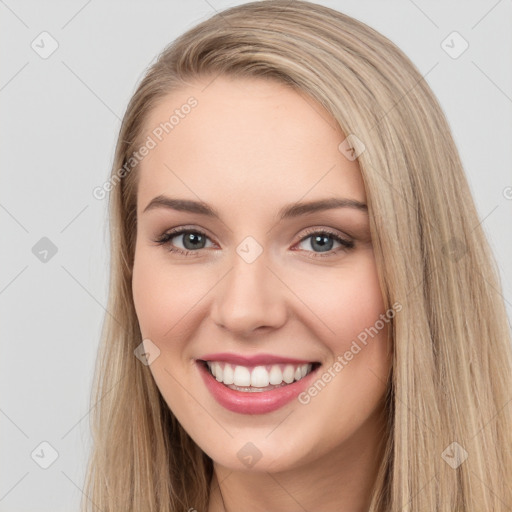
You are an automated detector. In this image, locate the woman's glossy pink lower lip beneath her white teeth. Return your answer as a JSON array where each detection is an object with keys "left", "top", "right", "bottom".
[{"left": 197, "top": 361, "right": 318, "bottom": 414}]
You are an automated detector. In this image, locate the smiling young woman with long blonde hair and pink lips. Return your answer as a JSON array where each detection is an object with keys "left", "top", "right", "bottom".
[{"left": 84, "top": 0, "right": 512, "bottom": 512}]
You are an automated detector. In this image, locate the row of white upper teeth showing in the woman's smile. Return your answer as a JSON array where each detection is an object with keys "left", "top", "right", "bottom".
[{"left": 207, "top": 361, "right": 312, "bottom": 388}]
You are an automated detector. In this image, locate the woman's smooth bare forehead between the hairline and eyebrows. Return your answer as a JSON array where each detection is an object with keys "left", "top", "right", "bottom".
[{"left": 138, "top": 77, "right": 365, "bottom": 213}]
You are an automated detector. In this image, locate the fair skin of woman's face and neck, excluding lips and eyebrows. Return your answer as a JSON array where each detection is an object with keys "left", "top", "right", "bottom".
[{"left": 132, "top": 77, "right": 391, "bottom": 512}]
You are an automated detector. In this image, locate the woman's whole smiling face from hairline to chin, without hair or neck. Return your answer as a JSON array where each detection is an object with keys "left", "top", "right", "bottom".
[{"left": 132, "top": 77, "right": 390, "bottom": 471}]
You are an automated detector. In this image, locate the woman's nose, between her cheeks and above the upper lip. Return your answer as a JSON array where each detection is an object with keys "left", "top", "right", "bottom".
[{"left": 211, "top": 250, "right": 287, "bottom": 338}]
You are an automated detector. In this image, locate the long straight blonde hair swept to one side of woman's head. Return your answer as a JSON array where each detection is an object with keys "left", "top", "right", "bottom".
[{"left": 83, "top": 0, "right": 512, "bottom": 512}]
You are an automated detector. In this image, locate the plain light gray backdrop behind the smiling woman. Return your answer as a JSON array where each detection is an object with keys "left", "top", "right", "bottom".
[{"left": 0, "top": 0, "right": 512, "bottom": 512}]
